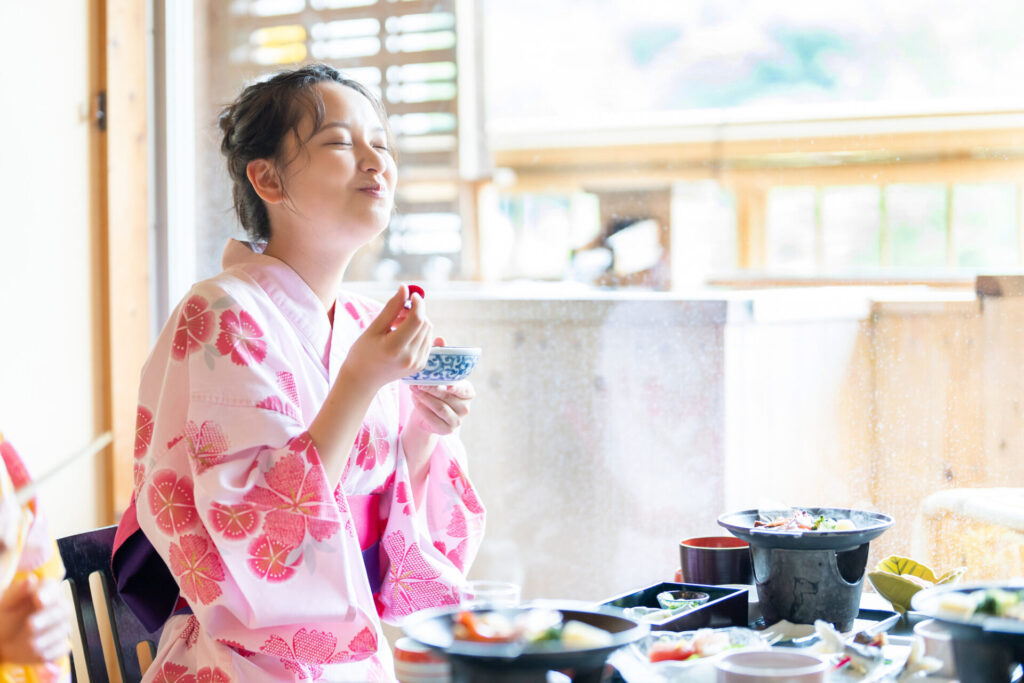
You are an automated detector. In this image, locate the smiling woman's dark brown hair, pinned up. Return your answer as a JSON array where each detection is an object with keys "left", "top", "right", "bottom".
[{"left": 219, "top": 63, "right": 394, "bottom": 242}]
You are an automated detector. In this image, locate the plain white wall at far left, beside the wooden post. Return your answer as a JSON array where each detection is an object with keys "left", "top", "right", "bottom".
[{"left": 0, "top": 0, "right": 102, "bottom": 536}]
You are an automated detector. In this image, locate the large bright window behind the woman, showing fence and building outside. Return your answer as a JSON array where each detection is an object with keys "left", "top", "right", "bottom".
[{"left": 153, "top": 0, "right": 1024, "bottom": 618}]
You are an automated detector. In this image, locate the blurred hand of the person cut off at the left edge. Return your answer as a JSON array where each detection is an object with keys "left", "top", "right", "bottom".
[{"left": 0, "top": 575, "right": 71, "bottom": 665}]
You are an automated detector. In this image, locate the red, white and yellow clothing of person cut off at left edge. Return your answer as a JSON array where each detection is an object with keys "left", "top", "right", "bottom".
[{"left": 0, "top": 434, "right": 71, "bottom": 683}]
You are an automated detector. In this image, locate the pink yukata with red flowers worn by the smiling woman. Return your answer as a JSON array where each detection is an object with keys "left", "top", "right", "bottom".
[{"left": 123, "top": 242, "right": 484, "bottom": 683}]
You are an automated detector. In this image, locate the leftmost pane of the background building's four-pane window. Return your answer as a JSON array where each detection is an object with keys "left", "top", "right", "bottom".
[{"left": 765, "top": 187, "right": 817, "bottom": 272}]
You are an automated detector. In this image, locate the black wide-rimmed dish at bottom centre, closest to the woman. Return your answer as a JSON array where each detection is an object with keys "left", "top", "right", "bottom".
[{"left": 402, "top": 601, "right": 650, "bottom": 683}]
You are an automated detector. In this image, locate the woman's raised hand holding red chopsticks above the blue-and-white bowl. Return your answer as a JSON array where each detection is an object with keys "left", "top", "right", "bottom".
[{"left": 342, "top": 285, "right": 433, "bottom": 392}]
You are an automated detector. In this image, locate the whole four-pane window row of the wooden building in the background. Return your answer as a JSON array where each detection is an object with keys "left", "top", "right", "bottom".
[{"left": 765, "top": 182, "right": 1024, "bottom": 275}]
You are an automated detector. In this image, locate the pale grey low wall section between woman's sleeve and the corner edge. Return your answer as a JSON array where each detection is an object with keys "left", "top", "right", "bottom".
[{"left": 419, "top": 292, "right": 728, "bottom": 600}]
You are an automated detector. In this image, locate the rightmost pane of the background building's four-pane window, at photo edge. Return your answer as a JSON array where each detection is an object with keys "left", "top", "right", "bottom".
[{"left": 952, "top": 184, "right": 1019, "bottom": 268}]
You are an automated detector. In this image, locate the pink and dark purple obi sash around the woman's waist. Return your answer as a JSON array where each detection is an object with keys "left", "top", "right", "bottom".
[{"left": 111, "top": 494, "right": 384, "bottom": 633}]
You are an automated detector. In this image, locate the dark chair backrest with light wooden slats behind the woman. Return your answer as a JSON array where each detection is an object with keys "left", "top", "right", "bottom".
[{"left": 57, "top": 525, "right": 160, "bottom": 683}]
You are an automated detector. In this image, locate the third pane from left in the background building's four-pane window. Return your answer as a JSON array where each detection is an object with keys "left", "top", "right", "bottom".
[{"left": 886, "top": 184, "right": 946, "bottom": 268}]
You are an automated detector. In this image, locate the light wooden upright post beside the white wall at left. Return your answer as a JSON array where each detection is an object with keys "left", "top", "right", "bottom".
[{"left": 105, "top": 0, "right": 150, "bottom": 519}]
